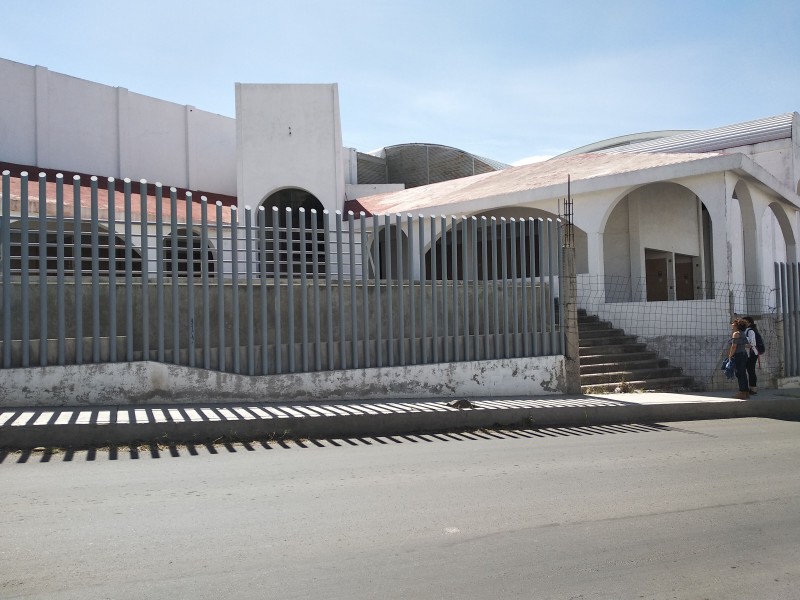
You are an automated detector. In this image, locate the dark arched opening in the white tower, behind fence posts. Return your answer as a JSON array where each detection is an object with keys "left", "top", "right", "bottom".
[{"left": 258, "top": 188, "right": 326, "bottom": 275}]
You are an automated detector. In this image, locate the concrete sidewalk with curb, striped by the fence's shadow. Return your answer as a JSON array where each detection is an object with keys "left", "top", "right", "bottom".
[{"left": 0, "top": 389, "right": 800, "bottom": 449}]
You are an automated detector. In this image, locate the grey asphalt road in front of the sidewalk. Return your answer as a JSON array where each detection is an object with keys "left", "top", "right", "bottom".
[{"left": 0, "top": 419, "right": 800, "bottom": 600}]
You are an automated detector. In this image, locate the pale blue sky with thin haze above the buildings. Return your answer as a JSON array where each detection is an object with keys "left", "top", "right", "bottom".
[{"left": 0, "top": 0, "right": 800, "bottom": 163}]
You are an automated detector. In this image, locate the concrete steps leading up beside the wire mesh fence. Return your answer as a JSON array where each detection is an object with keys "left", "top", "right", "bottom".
[{"left": 578, "top": 309, "right": 692, "bottom": 393}]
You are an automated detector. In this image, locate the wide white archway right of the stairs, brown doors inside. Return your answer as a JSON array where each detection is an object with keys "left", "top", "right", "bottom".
[{"left": 603, "top": 182, "right": 714, "bottom": 302}]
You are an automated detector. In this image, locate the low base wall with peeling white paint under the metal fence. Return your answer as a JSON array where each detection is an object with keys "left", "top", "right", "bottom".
[{"left": 0, "top": 355, "right": 567, "bottom": 407}]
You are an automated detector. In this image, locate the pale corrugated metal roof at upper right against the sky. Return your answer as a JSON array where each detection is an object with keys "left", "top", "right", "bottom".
[{"left": 601, "top": 113, "right": 796, "bottom": 154}]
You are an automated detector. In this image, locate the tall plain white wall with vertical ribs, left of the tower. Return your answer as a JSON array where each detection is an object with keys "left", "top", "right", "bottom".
[{"left": 0, "top": 59, "right": 236, "bottom": 195}]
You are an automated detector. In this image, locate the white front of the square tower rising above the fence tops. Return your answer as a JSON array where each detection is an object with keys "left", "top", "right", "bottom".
[{"left": 236, "top": 83, "right": 345, "bottom": 212}]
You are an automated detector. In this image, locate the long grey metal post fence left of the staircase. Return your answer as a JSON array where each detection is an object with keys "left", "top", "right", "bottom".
[{"left": 0, "top": 171, "right": 564, "bottom": 375}]
